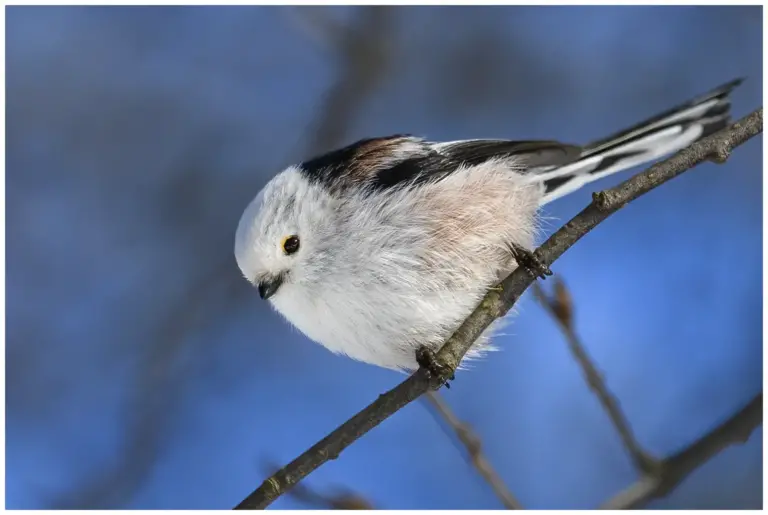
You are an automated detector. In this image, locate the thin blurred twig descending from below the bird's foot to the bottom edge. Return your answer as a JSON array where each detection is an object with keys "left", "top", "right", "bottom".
[{"left": 426, "top": 392, "right": 523, "bottom": 510}]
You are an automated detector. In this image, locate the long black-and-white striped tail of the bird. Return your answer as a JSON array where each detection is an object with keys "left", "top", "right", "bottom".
[{"left": 531, "top": 79, "right": 743, "bottom": 205}]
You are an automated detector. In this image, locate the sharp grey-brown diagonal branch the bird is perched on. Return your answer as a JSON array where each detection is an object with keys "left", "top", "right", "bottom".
[{"left": 236, "top": 101, "right": 763, "bottom": 509}]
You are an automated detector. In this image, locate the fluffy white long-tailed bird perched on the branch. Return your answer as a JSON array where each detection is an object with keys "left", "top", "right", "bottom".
[{"left": 234, "top": 79, "right": 743, "bottom": 373}]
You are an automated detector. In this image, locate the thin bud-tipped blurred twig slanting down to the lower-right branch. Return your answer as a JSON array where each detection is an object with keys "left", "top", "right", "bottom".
[{"left": 533, "top": 277, "right": 657, "bottom": 473}]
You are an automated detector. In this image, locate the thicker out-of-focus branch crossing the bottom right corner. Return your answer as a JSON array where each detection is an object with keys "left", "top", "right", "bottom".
[{"left": 601, "top": 392, "right": 763, "bottom": 510}]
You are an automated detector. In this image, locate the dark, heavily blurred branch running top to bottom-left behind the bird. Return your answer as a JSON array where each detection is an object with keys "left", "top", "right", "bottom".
[{"left": 49, "top": 6, "right": 395, "bottom": 509}]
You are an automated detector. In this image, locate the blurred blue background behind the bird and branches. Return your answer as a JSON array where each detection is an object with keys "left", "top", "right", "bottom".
[{"left": 6, "top": 7, "right": 763, "bottom": 509}]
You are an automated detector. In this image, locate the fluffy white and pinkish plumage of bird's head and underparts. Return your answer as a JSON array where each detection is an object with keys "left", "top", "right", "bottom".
[{"left": 236, "top": 160, "right": 540, "bottom": 370}]
